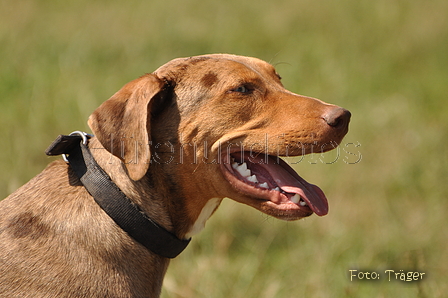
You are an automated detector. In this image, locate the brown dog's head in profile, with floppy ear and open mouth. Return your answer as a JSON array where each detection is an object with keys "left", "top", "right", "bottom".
[{"left": 89, "top": 54, "right": 350, "bottom": 237}]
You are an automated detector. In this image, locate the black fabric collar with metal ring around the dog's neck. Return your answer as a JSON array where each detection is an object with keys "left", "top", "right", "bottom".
[{"left": 45, "top": 132, "right": 190, "bottom": 258}]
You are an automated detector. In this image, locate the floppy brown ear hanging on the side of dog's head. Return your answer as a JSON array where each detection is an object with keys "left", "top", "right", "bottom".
[{"left": 88, "top": 74, "right": 164, "bottom": 181}]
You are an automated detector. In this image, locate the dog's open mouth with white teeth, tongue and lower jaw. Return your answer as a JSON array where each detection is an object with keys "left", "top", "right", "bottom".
[{"left": 221, "top": 152, "right": 328, "bottom": 220}]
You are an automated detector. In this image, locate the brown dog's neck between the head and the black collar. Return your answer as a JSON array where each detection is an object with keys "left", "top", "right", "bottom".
[{"left": 89, "top": 137, "right": 222, "bottom": 244}]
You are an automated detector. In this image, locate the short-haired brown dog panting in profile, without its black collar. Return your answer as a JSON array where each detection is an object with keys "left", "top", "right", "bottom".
[{"left": 0, "top": 54, "right": 350, "bottom": 298}]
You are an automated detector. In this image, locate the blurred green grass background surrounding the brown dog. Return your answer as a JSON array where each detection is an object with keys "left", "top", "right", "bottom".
[{"left": 0, "top": 0, "right": 448, "bottom": 298}]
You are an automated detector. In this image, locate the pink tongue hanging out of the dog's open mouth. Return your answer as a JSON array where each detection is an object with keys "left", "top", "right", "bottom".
[{"left": 255, "top": 157, "right": 328, "bottom": 216}]
